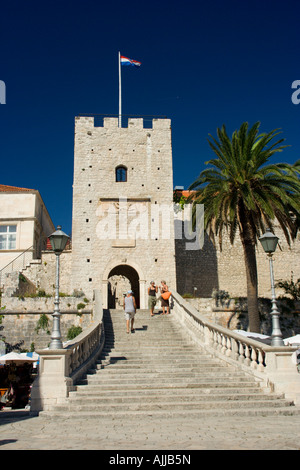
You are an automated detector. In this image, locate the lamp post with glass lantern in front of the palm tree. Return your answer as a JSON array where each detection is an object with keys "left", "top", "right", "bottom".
[{"left": 259, "top": 229, "right": 284, "bottom": 346}]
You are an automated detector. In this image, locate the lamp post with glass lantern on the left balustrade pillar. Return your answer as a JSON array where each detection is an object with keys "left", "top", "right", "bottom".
[{"left": 49, "top": 225, "right": 69, "bottom": 349}]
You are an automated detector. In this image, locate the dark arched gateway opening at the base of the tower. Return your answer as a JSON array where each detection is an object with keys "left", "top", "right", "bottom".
[{"left": 108, "top": 264, "right": 140, "bottom": 308}]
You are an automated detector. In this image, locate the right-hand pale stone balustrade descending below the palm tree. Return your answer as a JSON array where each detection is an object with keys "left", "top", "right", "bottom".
[{"left": 172, "top": 293, "right": 300, "bottom": 405}]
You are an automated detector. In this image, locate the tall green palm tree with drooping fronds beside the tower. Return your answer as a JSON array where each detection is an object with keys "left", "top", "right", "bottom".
[{"left": 189, "top": 122, "right": 300, "bottom": 332}]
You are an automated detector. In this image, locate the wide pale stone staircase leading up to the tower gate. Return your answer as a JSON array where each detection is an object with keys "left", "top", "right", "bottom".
[{"left": 41, "top": 310, "right": 299, "bottom": 419}]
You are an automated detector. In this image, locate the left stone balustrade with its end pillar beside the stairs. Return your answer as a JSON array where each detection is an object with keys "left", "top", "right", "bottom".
[{"left": 30, "top": 291, "right": 105, "bottom": 414}]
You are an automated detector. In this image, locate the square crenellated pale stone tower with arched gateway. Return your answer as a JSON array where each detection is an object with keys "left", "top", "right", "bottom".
[{"left": 72, "top": 116, "right": 176, "bottom": 308}]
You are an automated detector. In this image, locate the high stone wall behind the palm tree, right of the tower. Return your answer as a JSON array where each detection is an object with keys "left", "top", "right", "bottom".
[{"left": 175, "top": 221, "right": 300, "bottom": 297}]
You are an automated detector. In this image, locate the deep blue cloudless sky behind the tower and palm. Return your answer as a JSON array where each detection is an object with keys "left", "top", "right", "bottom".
[{"left": 0, "top": 0, "right": 300, "bottom": 233}]
